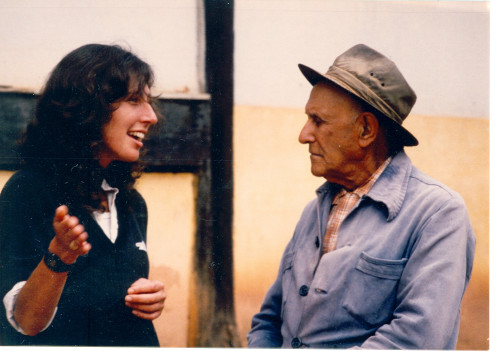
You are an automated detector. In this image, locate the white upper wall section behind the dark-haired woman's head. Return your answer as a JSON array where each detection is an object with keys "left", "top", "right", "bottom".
[{"left": 0, "top": 0, "right": 198, "bottom": 93}]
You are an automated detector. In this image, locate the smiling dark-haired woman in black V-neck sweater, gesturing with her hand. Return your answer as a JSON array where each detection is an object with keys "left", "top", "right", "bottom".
[{"left": 0, "top": 44, "right": 165, "bottom": 346}]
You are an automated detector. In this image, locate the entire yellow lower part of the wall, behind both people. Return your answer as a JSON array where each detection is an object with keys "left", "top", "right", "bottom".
[{"left": 0, "top": 106, "right": 489, "bottom": 349}]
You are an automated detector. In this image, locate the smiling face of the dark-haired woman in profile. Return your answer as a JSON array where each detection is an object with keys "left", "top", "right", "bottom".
[{"left": 97, "top": 87, "right": 158, "bottom": 168}]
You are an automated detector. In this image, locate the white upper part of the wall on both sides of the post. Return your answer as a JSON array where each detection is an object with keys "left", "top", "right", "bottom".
[{"left": 0, "top": 0, "right": 490, "bottom": 117}]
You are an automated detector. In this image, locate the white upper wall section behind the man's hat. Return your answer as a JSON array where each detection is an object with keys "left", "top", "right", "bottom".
[{"left": 235, "top": 0, "right": 489, "bottom": 117}]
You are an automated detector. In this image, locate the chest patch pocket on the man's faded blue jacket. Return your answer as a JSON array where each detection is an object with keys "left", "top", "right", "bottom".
[{"left": 342, "top": 252, "right": 408, "bottom": 329}]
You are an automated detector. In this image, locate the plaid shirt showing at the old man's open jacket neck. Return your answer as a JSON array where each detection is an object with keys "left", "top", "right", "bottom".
[{"left": 321, "top": 157, "right": 392, "bottom": 255}]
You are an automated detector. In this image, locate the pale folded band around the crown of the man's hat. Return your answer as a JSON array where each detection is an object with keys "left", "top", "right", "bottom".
[{"left": 324, "top": 66, "right": 403, "bottom": 125}]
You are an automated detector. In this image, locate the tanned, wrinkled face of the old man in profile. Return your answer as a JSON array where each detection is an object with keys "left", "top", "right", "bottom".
[{"left": 299, "top": 82, "right": 361, "bottom": 185}]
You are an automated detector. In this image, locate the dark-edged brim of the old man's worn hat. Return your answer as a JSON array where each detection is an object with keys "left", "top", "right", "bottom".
[{"left": 299, "top": 63, "right": 418, "bottom": 146}]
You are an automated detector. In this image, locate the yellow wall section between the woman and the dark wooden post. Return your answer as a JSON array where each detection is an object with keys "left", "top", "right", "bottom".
[{"left": 138, "top": 173, "right": 196, "bottom": 347}]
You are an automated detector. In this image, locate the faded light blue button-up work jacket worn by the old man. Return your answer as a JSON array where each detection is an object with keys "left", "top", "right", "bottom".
[{"left": 248, "top": 151, "right": 475, "bottom": 349}]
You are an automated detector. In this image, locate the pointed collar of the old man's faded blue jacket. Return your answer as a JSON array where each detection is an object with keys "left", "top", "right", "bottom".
[{"left": 316, "top": 151, "right": 413, "bottom": 221}]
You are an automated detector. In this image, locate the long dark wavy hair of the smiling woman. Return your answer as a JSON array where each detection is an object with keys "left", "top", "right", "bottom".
[{"left": 20, "top": 44, "right": 154, "bottom": 207}]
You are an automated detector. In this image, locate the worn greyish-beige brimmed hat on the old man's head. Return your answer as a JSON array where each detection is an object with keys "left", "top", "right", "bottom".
[{"left": 299, "top": 44, "right": 418, "bottom": 146}]
